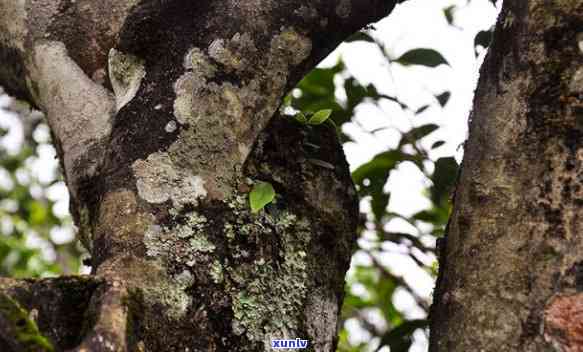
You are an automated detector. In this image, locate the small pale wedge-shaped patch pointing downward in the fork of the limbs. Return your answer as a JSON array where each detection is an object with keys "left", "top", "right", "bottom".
[{"left": 108, "top": 48, "right": 146, "bottom": 111}]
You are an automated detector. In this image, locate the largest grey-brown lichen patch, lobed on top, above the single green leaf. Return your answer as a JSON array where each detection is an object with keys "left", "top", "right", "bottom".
[{"left": 168, "top": 28, "right": 312, "bottom": 200}]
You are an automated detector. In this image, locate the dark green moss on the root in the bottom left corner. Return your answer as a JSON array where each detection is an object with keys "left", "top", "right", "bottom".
[{"left": 0, "top": 293, "right": 54, "bottom": 352}]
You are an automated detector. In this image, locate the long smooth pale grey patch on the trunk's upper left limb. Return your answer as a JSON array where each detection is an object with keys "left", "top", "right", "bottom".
[{"left": 30, "top": 41, "right": 115, "bottom": 192}]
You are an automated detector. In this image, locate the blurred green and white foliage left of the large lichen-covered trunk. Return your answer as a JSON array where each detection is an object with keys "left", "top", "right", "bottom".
[{"left": 0, "top": 104, "right": 82, "bottom": 278}]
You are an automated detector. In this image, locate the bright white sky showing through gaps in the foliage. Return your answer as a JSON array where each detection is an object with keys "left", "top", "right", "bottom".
[{"left": 0, "top": 0, "right": 497, "bottom": 352}]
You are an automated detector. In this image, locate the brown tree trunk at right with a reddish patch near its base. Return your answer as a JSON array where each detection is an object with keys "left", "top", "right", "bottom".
[{"left": 431, "top": 0, "right": 583, "bottom": 352}]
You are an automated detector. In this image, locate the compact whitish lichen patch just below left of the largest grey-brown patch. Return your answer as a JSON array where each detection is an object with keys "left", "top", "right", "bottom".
[{"left": 132, "top": 152, "right": 207, "bottom": 209}]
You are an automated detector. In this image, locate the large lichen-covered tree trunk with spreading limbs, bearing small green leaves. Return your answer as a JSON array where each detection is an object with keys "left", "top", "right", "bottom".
[{"left": 0, "top": 0, "right": 395, "bottom": 351}]
